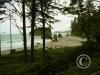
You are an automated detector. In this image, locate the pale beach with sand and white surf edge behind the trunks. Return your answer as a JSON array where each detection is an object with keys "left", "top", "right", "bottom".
[{"left": 2, "top": 36, "right": 86, "bottom": 54}]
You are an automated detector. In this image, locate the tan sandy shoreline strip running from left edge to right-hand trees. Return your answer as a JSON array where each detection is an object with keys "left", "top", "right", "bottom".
[{"left": 1, "top": 36, "right": 86, "bottom": 54}]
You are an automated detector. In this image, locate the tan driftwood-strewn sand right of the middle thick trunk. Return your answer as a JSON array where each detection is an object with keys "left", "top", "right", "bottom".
[{"left": 35, "top": 36, "right": 86, "bottom": 49}]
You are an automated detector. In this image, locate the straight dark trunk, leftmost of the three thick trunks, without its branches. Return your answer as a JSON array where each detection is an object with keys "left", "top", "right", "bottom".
[{"left": 22, "top": 0, "right": 27, "bottom": 63}]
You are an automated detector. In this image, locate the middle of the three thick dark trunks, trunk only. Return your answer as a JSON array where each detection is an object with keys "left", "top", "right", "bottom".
[{"left": 31, "top": 0, "right": 36, "bottom": 63}]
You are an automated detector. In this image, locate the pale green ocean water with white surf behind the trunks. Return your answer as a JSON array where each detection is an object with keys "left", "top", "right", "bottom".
[{"left": 1, "top": 34, "right": 51, "bottom": 51}]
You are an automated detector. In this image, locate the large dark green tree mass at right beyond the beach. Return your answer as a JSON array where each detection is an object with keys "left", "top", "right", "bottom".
[{"left": 71, "top": 0, "right": 100, "bottom": 41}]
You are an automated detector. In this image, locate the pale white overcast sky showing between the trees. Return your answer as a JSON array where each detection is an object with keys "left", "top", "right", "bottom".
[{"left": 0, "top": 0, "right": 75, "bottom": 34}]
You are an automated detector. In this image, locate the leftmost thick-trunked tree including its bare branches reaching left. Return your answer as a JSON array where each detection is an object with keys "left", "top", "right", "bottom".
[{"left": 6, "top": 0, "right": 27, "bottom": 63}]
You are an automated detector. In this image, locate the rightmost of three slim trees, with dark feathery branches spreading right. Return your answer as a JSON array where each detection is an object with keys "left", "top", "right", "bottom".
[{"left": 40, "top": 0, "right": 61, "bottom": 57}]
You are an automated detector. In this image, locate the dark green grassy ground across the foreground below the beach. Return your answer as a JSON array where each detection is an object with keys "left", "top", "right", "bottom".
[{"left": 0, "top": 46, "right": 100, "bottom": 75}]
